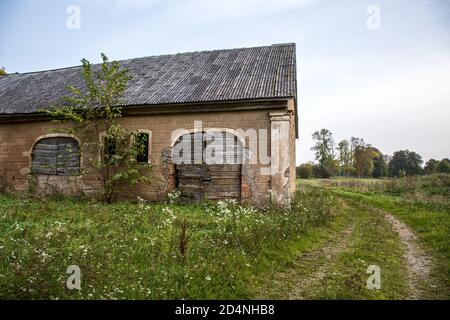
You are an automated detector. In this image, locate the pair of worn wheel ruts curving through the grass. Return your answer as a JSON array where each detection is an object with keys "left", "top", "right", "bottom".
[{"left": 257, "top": 198, "right": 433, "bottom": 300}]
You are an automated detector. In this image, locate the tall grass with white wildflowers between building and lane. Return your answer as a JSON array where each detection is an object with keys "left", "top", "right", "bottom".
[{"left": 0, "top": 189, "right": 334, "bottom": 299}]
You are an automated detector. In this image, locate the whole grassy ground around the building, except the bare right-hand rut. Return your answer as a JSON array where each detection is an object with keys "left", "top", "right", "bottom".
[{"left": 0, "top": 175, "right": 450, "bottom": 299}]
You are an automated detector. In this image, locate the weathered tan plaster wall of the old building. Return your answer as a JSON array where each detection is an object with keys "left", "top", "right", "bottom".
[{"left": 0, "top": 103, "right": 295, "bottom": 205}]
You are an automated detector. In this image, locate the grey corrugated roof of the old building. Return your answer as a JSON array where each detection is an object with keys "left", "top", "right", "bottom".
[{"left": 0, "top": 44, "right": 296, "bottom": 114}]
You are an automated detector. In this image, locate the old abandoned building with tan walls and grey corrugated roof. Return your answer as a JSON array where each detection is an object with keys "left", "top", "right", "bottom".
[{"left": 0, "top": 44, "right": 297, "bottom": 205}]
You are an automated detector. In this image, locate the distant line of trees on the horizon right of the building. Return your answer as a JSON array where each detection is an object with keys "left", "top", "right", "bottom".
[{"left": 297, "top": 129, "right": 450, "bottom": 179}]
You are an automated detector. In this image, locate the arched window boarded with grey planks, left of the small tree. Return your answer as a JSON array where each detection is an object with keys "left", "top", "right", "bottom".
[{"left": 31, "top": 137, "right": 80, "bottom": 176}]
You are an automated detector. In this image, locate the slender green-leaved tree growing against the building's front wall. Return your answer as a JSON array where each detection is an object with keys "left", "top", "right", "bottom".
[{"left": 45, "top": 54, "right": 148, "bottom": 203}]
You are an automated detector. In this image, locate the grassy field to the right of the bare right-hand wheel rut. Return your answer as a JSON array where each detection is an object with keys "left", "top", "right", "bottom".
[{"left": 300, "top": 174, "right": 450, "bottom": 299}]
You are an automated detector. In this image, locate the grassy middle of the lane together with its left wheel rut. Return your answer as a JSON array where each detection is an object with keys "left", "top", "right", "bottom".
[{"left": 255, "top": 195, "right": 409, "bottom": 299}]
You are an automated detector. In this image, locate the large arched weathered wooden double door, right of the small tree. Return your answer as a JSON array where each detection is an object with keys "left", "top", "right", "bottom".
[{"left": 176, "top": 132, "right": 242, "bottom": 201}]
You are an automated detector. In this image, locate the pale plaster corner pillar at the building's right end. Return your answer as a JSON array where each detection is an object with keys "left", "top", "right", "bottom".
[{"left": 269, "top": 111, "right": 293, "bottom": 207}]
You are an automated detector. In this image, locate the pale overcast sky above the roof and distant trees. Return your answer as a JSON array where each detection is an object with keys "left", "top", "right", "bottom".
[{"left": 0, "top": 0, "right": 450, "bottom": 163}]
